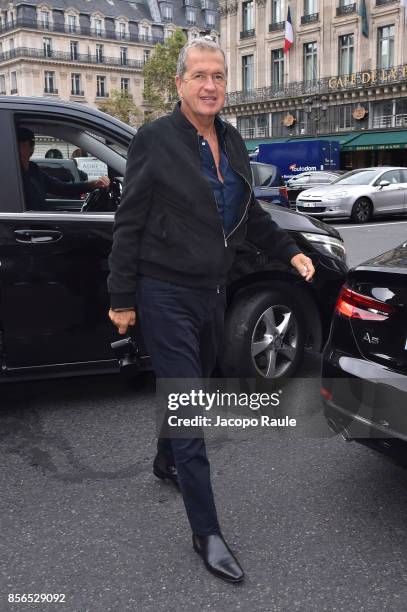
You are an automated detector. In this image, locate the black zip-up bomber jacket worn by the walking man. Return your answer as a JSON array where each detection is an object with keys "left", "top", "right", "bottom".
[{"left": 108, "top": 103, "right": 300, "bottom": 308}]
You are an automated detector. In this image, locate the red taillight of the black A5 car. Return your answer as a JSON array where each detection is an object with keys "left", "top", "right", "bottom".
[{"left": 335, "top": 286, "right": 395, "bottom": 321}]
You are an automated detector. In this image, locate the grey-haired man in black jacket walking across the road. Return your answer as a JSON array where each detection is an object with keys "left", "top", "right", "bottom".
[{"left": 108, "top": 38, "right": 314, "bottom": 582}]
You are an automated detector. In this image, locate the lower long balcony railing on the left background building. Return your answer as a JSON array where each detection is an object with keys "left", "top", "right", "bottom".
[{"left": 0, "top": 47, "right": 144, "bottom": 70}]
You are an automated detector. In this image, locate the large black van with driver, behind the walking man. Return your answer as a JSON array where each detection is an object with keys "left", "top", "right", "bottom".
[{"left": 0, "top": 96, "right": 347, "bottom": 381}]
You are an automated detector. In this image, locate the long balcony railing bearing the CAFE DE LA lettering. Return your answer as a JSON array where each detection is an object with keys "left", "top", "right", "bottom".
[{"left": 225, "top": 65, "right": 407, "bottom": 106}]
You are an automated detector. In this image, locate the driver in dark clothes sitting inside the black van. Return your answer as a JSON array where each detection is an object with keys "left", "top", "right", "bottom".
[{"left": 17, "top": 127, "right": 110, "bottom": 210}]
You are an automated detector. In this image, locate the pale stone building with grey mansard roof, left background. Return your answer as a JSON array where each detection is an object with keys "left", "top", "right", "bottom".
[{"left": 0, "top": 0, "right": 219, "bottom": 108}]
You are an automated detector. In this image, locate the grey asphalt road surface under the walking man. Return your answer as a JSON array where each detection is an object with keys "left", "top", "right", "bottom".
[{"left": 0, "top": 223, "right": 407, "bottom": 612}]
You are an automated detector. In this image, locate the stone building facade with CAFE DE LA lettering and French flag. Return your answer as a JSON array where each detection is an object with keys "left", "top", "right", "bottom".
[{"left": 219, "top": 0, "right": 407, "bottom": 168}]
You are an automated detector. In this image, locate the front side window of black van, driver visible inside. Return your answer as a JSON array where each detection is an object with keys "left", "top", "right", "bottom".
[{"left": 16, "top": 119, "right": 127, "bottom": 212}]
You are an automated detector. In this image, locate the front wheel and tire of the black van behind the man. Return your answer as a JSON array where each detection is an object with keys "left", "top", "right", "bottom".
[{"left": 220, "top": 289, "right": 306, "bottom": 382}]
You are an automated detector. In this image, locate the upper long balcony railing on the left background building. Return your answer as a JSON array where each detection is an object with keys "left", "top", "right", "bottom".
[{"left": 0, "top": 19, "right": 164, "bottom": 45}]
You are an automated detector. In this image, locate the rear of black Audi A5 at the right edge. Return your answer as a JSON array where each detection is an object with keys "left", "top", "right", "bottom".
[{"left": 321, "top": 242, "right": 407, "bottom": 462}]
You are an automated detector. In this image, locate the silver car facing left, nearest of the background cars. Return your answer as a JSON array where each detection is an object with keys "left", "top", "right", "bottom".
[{"left": 297, "top": 166, "right": 407, "bottom": 223}]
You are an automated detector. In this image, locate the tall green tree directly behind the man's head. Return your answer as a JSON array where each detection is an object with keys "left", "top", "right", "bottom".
[{"left": 143, "top": 28, "right": 187, "bottom": 120}]
